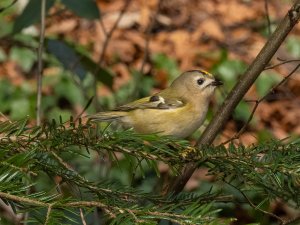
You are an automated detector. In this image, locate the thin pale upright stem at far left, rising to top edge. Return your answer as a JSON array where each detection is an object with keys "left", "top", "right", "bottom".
[{"left": 36, "top": 0, "right": 46, "bottom": 126}]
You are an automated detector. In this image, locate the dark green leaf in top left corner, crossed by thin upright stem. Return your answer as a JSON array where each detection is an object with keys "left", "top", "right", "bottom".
[{"left": 12, "top": 0, "right": 54, "bottom": 34}]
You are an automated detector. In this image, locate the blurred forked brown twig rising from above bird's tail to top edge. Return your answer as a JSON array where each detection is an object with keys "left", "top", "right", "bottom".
[{"left": 94, "top": 0, "right": 132, "bottom": 111}]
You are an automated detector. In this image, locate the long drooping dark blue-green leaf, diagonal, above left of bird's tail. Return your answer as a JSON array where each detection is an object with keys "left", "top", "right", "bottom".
[{"left": 47, "top": 39, "right": 113, "bottom": 88}]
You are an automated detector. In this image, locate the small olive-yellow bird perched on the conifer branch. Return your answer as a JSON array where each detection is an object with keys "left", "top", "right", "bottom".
[{"left": 89, "top": 70, "right": 223, "bottom": 138}]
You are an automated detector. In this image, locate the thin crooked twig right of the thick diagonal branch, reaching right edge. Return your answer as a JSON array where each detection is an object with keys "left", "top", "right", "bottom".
[{"left": 220, "top": 64, "right": 300, "bottom": 145}]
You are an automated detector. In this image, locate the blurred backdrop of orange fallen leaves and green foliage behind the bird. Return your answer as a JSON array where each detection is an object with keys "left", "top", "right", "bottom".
[{"left": 0, "top": 0, "right": 300, "bottom": 224}]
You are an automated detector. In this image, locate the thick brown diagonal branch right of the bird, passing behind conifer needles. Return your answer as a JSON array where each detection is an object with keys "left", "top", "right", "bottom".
[{"left": 168, "top": 0, "right": 300, "bottom": 194}]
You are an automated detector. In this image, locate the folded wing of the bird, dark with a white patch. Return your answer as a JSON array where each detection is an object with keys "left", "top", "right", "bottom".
[{"left": 114, "top": 94, "right": 185, "bottom": 111}]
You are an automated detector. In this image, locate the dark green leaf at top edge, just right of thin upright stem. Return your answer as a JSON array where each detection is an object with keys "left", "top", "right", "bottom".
[{"left": 61, "top": 0, "right": 100, "bottom": 20}]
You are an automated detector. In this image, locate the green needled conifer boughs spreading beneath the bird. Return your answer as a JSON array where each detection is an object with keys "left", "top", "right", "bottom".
[{"left": 0, "top": 120, "right": 300, "bottom": 225}]
